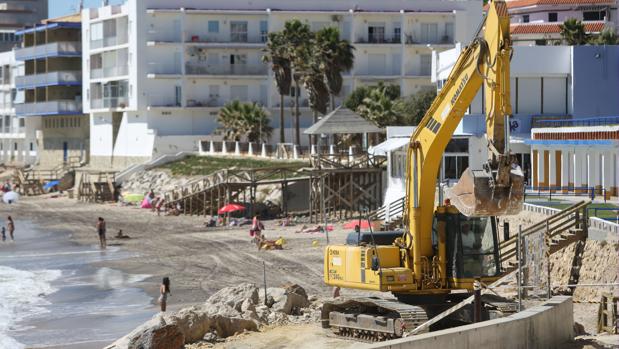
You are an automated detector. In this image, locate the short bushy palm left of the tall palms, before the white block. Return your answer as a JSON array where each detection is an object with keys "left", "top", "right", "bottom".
[{"left": 217, "top": 100, "right": 273, "bottom": 142}]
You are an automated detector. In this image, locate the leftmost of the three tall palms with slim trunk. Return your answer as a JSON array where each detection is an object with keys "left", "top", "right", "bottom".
[{"left": 262, "top": 32, "right": 292, "bottom": 143}]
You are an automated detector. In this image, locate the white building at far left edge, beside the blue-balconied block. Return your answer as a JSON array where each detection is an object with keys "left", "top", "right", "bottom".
[{"left": 0, "top": 51, "right": 40, "bottom": 165}]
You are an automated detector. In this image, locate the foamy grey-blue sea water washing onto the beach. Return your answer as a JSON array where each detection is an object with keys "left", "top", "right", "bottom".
[{"left": 0, "top": 221, "right": 156, "bottom": 349}]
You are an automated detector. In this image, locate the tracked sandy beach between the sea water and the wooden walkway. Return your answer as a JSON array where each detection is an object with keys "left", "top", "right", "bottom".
[{"left": 1, "top": 196, "right": 354, "bottom": 310}]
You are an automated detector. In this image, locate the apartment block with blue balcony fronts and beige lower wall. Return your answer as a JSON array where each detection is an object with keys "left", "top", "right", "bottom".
[{"left": 15, "top": 15, "right": 90, "bottom": 168}]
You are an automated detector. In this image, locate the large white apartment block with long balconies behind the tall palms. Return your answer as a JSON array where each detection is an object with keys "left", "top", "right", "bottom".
[{"left": 82, "top": 0, "right": 482, "bottom": 168}]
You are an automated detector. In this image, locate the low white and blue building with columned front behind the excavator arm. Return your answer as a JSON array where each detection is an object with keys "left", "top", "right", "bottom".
[{"left": 433, "top": 45, "right": 619, "bottom": 195}]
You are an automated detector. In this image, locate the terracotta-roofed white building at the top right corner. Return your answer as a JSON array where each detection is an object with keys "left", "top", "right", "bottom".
[{"left": 507, "top": 0, "right": 619, "bottom": 45}]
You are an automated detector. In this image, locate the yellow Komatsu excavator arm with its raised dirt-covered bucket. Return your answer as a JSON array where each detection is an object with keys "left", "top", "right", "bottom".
[{"left": 405, "top": 1, "right": 524, "bottom": 284}]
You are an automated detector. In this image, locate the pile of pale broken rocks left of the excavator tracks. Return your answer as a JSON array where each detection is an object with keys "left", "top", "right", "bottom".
[{"left": 106, "top": 283, "right": 320, "bottom": 349}]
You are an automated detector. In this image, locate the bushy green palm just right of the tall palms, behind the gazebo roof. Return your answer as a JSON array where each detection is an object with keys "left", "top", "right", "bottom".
[{"left": 357, "top": 87, "right": 401, "bottom": 127}]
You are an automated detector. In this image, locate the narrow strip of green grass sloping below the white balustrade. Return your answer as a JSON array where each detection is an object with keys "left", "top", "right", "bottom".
[{"left": 160, "top": 156, "right": 309, "bottom": 176}]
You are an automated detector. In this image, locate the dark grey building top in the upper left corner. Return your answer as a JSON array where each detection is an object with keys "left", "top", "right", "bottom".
[{"left": 0, "top": 0, "right": 48, "bottom": 52}]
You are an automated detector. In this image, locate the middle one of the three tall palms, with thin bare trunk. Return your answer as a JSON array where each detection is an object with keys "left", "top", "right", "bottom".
[{"left": 282, "top": 19, "right": 313, "bottom": 144}]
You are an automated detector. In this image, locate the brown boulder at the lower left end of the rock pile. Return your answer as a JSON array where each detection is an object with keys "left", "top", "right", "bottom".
[{"left": 127, "top": 323, "right": 185, "bottom": 349}]
